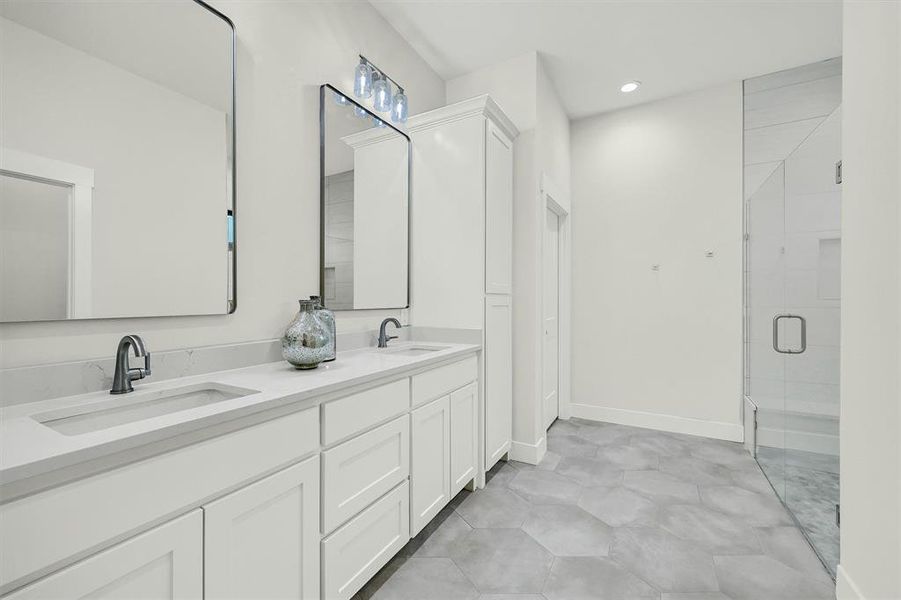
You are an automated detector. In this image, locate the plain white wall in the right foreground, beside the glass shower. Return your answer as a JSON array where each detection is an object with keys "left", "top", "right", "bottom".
[{"left": 837, "top": 2, "right": 901, "bottom": 600}]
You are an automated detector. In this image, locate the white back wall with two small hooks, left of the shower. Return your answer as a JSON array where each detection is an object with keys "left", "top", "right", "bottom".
[{"left": 572, "top": 82, "right": 742, "bottom": 440}]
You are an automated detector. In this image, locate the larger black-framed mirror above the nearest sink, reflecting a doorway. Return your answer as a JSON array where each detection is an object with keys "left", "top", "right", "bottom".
[{"left": 0, "top": 0, "right": 237, "bottom": 322}]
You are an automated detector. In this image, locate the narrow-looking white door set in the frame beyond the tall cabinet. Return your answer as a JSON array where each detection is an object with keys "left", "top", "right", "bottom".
[{"left": 542, "top": 208, "right": 560, "bottom": 428}]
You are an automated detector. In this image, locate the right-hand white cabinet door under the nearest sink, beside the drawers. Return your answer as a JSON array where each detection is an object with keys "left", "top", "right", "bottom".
[{"left": 203, "top": 456, "right": 319, "bottom": 600}]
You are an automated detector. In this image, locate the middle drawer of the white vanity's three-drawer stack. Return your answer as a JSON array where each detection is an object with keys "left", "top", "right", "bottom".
[{"left": 322, "top": 415, "right": 410, "bottom": 533}]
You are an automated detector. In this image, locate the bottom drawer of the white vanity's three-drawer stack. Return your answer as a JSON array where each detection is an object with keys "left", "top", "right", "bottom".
[{"left": 322, "top": 481, "right": 410, "bottom": 600}]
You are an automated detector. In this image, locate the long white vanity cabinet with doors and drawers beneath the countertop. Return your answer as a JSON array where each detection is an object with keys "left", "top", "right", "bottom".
[{"left": 0, "top": 349, "right": 480, "bottom": 600}]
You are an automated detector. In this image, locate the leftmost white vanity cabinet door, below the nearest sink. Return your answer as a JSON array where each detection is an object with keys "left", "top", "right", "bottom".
[{"left": 4, "top": 509, "right": 203, "bottom": 600}]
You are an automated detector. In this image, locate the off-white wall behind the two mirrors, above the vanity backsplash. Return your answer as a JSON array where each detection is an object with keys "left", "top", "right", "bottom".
[{"left": 0, "top": 0, "right": 445, "bottom": 367}]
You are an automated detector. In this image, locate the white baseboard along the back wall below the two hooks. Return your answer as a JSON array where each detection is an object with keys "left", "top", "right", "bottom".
[{"left": 570, "top": 404, "right": 744, "bottom": 442}]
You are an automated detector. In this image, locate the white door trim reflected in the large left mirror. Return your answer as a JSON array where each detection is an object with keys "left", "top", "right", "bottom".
[{"left": 0, "top": 147, "right": 94, "bottom": 319}]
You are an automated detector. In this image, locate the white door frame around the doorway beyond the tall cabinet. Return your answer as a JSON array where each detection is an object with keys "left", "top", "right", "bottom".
[{"left": 538, "top": 173, "right": 572, "bottom": 422}]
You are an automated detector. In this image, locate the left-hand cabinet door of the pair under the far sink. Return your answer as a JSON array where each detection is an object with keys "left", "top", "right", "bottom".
[{"left": 410, "top": 396, "right": 450, "bottom": 535}]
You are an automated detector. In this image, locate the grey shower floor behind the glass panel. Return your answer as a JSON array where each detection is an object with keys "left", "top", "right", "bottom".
[{"left": 757, "top": 447, "right": 839, "bottom": 577}]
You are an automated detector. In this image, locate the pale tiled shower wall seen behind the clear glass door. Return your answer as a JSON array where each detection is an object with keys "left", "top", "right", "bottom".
[{"left": 745, "top": 59, "right": 841, "bottom": 454}]
